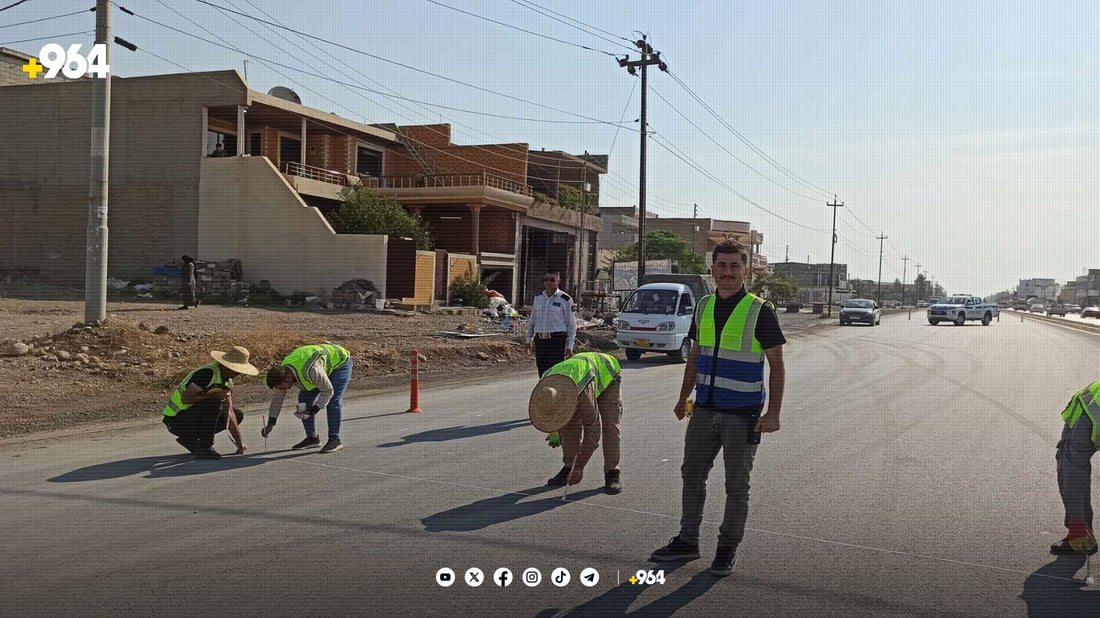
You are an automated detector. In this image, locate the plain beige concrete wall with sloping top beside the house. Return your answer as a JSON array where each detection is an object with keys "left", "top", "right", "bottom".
[{"left": 198, "top": 157, "right": 387, "bottom": 298}]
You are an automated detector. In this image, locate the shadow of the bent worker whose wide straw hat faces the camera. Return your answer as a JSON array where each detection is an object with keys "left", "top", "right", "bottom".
[{"left": 420, "top": 485, "right": 604, "bottom": 532}]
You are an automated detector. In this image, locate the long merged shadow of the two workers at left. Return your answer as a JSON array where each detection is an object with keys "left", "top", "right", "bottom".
[{"left": 48, "top": 451, "right": 310, "bottom": 483}]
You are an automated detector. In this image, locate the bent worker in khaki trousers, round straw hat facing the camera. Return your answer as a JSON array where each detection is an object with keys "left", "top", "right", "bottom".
[{"left": 527, "top": 352, "right": 623, "bottom": 494}]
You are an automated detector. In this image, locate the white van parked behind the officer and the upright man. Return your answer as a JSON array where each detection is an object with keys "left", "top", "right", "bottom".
[{"left": 615, "top": 284, "right": 696, "bottom": 361}]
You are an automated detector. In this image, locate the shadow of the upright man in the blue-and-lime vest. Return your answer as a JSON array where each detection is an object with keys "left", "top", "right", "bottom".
[{"left": 543, "top": 562, "right": 718, "bottom": 616}]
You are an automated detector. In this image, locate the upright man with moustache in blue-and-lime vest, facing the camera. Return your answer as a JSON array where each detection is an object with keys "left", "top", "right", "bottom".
[{"left": 650, "top": 241, "right": 787, "bottom": 577}]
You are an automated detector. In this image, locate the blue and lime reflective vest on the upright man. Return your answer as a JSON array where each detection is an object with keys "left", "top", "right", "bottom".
[{"left": 694, "top": 294, "right": 767, "bottom": 408}]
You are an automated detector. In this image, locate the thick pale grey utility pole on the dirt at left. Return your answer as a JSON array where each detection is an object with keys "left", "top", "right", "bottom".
[{"left": 84, "top": 0, "right": 111, "bottom": 322}]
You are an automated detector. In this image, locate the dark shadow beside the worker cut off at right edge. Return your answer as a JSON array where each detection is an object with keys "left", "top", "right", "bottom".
[{"left": 1020, "top": 555, "right": 1100, "bottom": 616}]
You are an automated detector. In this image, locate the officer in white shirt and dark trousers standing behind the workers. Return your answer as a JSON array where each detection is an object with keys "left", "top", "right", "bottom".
[{"left": 527, "top": 269, "right": 576, "bottom": 377}]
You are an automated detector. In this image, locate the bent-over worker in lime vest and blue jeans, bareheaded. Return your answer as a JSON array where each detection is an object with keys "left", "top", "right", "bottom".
[{"left": 261, "top": 343, "right": 352, "bottom": 453}]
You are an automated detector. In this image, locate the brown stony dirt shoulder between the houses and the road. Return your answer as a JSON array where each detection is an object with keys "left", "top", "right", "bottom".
[{"left": 0, "top": 287, "right": 824, "bottom": 441}]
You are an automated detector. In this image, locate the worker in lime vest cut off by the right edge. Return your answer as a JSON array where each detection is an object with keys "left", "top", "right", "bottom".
[{"left": 1051, "top": 380, "right": 1100, "bottom": 555}]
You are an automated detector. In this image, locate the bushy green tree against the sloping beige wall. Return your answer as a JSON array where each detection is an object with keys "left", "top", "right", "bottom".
[{"left": 328, "top": 185, "right": 432, "bottom": 251}]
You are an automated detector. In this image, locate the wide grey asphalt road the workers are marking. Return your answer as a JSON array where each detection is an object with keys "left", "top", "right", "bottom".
[{"left": 0, "top": 311, "right": 1100, "bottom": 617}]
